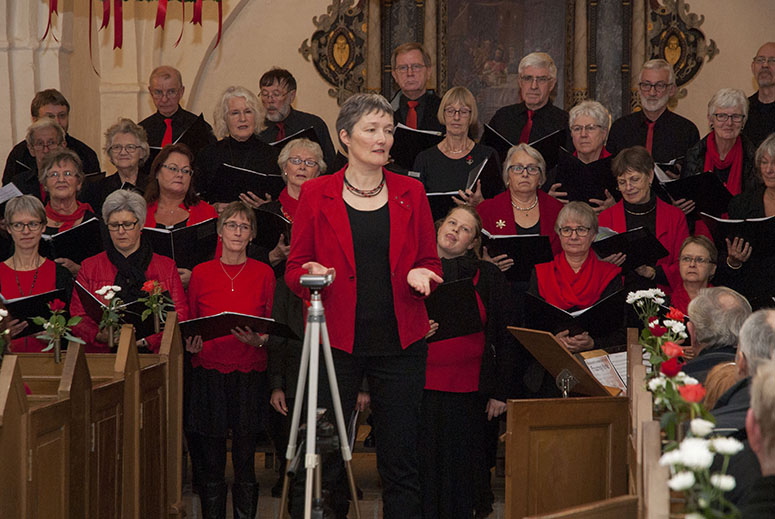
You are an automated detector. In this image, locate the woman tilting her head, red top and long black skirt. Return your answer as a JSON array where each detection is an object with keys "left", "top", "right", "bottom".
[{"left": 419, "top": 205, "right": 515, "bottom": 519}]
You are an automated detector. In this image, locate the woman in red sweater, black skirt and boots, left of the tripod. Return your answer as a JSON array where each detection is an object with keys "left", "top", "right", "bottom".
[{"left": 186, "top": 202, "right": 275, "bottom": 519}]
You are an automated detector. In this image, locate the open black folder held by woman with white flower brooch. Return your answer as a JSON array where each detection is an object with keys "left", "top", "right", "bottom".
[{"left": 482, "top": 231, "right": 554, "bottom": 281}]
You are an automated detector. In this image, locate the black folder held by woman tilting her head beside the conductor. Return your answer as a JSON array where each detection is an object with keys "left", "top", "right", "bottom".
[{"left": 425, "top": 278, "right": 483, "bottom": 342}]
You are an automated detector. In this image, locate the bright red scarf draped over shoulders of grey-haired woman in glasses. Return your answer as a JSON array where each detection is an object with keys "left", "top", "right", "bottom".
[{"left": 536, "top": 252, "right": 621, "bottom": 310}]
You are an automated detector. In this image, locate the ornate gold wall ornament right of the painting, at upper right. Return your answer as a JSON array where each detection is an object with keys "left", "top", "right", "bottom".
[{"left": 648, "top": 0, "right": 719, "bottom": 98}]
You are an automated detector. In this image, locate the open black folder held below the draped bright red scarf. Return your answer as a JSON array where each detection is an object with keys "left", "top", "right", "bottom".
[{"left": 525, "top": 290, "right": 625, "bottom": 338}]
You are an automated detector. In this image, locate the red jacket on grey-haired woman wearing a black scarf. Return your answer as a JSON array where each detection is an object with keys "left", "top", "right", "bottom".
[{"left": 70, "top": 252, "right": 188, "bottom": 353}]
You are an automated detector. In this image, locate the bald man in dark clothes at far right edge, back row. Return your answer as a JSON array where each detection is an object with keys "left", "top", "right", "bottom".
[{"left": 743, "top": 41, "right": 775, "bottom": 147}]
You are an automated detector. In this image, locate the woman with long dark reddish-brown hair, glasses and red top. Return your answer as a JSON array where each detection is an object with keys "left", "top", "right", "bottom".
[{"left": 145, "top": 144, "right": 221, "bottom": 287}]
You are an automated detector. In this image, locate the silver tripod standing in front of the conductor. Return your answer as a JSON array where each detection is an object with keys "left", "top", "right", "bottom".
[{"left": 278, "top": 274, "right": 361, "bottom": 519}]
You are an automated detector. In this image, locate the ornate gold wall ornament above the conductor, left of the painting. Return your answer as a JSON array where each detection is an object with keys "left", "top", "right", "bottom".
[{"left": 299, "top": 0, "right": 367, "bottom": 105}]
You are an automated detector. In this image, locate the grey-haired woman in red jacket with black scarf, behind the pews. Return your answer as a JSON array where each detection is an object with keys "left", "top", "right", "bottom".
[{"left": 70, "top": 189, "right": 188, "bottom": 353}]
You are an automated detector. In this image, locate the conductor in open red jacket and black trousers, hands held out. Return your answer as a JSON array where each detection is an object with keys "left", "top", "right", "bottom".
[{"left": 285, "top": 94, "right": 442, "bottom": 519}]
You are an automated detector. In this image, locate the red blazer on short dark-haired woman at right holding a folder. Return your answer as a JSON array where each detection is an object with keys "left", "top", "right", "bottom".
[{"left": 598, "top": 198, "right": 689, "bottom": 290}]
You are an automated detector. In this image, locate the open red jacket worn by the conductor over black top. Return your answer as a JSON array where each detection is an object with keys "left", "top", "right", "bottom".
[{"left": 285, "top": 169, "right": 441, "bottom": 353}]
